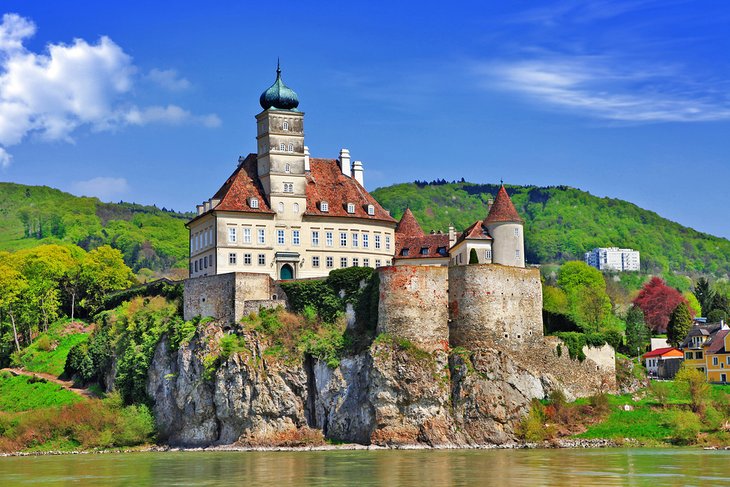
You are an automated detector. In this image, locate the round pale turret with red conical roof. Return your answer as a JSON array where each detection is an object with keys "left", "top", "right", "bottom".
[{"left": 484, "top": 184, "right": 525, "bottom": 267}]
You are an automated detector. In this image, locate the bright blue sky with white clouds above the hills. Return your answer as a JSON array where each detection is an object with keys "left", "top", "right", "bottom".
[{"left": 0, "top": 0, "right": 730, "bottom": 238}]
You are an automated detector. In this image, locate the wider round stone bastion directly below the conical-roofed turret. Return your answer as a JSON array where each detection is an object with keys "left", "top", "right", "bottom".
[{"left": 448, "top": 264, "right": 542, "bottom": 350}]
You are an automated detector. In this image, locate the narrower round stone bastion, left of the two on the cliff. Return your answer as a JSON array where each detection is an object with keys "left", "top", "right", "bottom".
[{"left": 377, "top": 265, "right": 449, "bottom": 351}]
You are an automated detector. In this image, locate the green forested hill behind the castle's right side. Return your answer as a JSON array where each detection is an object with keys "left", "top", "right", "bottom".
[{"left": 372, "top": 181, "right": 730, "bottom": 276}]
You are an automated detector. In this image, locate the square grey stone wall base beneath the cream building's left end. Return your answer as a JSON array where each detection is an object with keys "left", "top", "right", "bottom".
[{"left": 183, "top": 272, "right": 273, "bottom": 324}]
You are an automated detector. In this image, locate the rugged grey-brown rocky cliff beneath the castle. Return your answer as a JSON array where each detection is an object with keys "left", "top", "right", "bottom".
[{"left": 147, "top": 324, "right": 602, "bottom": 446}]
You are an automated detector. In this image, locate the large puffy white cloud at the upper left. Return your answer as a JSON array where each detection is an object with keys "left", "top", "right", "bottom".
[{"left": 0, "top": 14, "right": 220, "bottom": 166}]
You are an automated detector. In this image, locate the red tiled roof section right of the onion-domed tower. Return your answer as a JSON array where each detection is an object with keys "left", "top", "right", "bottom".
[{"left": 304, "top": 158, "right": 395, "bottom": 223}]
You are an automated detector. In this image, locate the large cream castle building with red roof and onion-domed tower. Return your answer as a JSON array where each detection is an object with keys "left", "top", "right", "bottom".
[{"left": 187, "top": 67, "right": 396, "bottom": 279}]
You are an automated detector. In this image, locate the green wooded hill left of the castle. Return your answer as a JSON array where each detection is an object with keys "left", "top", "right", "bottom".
[{"left": 0, "top": 183, "right": 192, "bottom": 272}]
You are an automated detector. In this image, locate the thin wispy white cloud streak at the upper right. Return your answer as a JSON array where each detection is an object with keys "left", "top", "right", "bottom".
[{"left": 476, "top": 54, "right": 730, "bottom": 122}]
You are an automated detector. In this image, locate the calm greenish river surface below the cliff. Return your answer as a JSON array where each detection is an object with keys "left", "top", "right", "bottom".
[{"left": 0, "top": 449, "right": 730, "bottom": 487}]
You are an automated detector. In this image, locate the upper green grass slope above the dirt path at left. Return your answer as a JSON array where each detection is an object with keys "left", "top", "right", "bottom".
[{"left": 13, "top": 320, "right": 89, "bottom": 377}]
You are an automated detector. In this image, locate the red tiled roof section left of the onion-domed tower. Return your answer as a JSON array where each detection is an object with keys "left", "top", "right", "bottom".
[{"left": 213, "top": 154, "right": 273, "bottom": 213}]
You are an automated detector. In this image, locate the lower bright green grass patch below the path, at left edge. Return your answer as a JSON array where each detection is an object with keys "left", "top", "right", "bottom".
[{"left": 0, "top": 373, "right": 82, "bottom": 412}]
